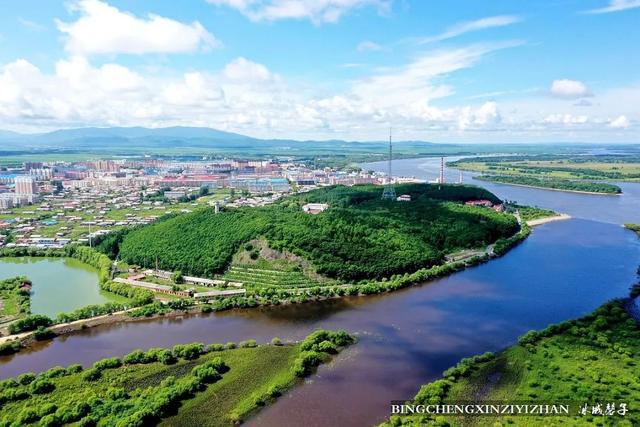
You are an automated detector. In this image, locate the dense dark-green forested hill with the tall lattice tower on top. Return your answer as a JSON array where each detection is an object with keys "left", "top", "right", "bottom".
[{"left": 120, "top": 184, "right": 518, "bottom": 281}]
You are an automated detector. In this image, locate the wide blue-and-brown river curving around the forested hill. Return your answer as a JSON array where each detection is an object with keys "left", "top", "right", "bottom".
[{"left": 0, "top": 159, "right": 640, "bottom": 426}]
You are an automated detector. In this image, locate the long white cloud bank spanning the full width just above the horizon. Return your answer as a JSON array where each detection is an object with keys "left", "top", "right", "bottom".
[{"left": 0, "top": 45, "right": 640, "bottom": 141}]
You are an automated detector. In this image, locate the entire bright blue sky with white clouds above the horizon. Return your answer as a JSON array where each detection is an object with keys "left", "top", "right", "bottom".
[{"left": 0, "top": 0, "right": 640, "bottom": 142}]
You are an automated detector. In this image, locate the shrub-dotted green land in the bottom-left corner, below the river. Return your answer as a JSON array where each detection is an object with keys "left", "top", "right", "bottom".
[{"left": 0, "top": 331, "right": 354, "bottom": 426}]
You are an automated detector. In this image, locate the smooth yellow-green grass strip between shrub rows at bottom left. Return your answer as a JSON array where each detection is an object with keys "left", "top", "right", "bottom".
[{"left": 162, "top": 345, "right": 299, "bottom": 426}]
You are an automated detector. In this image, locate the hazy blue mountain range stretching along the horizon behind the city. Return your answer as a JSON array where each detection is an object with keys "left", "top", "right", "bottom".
[{"left": 0, "top": 126, "right": 624, "bottom": 163}]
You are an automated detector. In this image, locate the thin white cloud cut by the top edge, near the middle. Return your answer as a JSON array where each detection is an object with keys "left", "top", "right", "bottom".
[{"left": 207, "top": 0, "right": 393, "bottom": 24}]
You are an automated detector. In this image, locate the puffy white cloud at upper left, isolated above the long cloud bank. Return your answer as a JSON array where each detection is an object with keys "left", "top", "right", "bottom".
[{"left": 56, "top": 0, "right": 219, "bottom": 55}]
